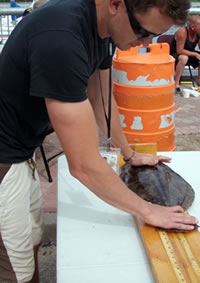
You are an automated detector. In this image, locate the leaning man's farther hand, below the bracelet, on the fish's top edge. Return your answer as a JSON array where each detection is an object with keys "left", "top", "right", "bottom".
[{"left": 130, "top": 152, "right": 171, "bottom": 166}]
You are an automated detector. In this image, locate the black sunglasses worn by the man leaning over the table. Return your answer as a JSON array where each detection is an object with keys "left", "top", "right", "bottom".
[{"left": 124, "top": 0, "right": 162, "bottom": 38}]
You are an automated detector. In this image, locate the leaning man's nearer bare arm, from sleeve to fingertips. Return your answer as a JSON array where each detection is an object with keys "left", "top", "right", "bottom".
[{"left": 45, "top": 98, "right": 197, "bottom": 230}]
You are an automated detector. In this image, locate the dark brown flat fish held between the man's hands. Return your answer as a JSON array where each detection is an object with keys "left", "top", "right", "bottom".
[{"left": 120, "top": 163, "right": 195, "bottom": 232}]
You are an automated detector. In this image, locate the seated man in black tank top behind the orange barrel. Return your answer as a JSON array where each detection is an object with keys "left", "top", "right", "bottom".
[{"left": 170, "top": 16, "right": 200, "bottom": 93}]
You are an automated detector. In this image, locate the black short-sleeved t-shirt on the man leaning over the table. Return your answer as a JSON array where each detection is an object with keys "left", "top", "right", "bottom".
[{"left": 0, "top": 0, "right": 112, "bottom": 163}]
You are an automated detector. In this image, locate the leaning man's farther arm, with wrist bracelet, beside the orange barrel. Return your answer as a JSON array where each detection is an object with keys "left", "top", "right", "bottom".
[{"left": 87, "top": 70, "right": 171, "bottom": 166}]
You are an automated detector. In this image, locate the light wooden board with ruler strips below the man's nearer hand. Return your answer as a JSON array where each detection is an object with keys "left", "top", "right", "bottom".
[{"left": 136, "top": 219, "right": 200, "bottom": 283}]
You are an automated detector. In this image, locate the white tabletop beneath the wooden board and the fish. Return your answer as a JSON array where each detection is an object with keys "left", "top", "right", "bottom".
[{"left": 57, "top": 152, "right": 200, "bottom": 283}]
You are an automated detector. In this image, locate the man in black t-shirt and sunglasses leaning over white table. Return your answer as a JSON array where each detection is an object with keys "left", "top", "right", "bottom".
[{"left": 0, "top": 0, "right": 197, "bottom": 283}]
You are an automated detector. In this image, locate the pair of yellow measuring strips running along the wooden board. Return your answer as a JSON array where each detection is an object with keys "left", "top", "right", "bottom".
[{"left": 159, "top": 231, "right": 200, "bottom": 283}]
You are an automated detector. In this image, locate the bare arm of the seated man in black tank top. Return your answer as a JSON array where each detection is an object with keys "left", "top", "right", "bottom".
[{"left": 175, "top": 28, "right": 200, "bottom": 60}]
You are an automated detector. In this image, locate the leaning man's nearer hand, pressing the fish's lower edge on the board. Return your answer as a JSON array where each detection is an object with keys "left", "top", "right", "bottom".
[{"left": 143, "top": 203, "right": 198, "bottom": 231}]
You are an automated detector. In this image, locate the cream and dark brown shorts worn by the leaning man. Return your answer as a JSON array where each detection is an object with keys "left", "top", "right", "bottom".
[{"left": 0, "top": 161, "right": 43, "bottom": 283}]
